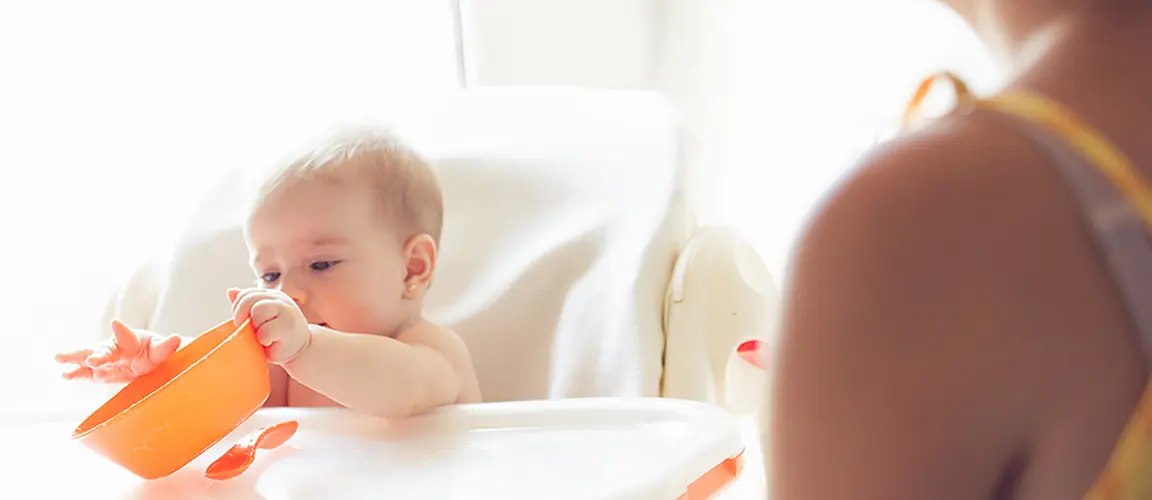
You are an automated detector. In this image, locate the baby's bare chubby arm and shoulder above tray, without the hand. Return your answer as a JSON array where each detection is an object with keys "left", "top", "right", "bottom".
[{"left": 283, "top": 325, "right": 471, "bottom": 417}]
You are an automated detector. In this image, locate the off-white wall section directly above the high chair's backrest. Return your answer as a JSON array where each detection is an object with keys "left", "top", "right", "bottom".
[{"left": 461, "top": 0, "right": 733, "bottom": 220}]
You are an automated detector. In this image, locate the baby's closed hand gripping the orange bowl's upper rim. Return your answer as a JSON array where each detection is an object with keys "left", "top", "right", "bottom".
[{"left": 228, "top": 288, "right": 312, "bottom": 364}]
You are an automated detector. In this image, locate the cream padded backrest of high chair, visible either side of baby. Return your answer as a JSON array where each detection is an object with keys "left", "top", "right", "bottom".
[{"left": 109, "top": 89, "right": 692, "bottom": 401}]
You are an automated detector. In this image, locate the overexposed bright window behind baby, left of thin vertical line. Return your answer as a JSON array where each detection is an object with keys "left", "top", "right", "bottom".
[{"left": 0, "top": 0, "right": 458, "bottom": 406}]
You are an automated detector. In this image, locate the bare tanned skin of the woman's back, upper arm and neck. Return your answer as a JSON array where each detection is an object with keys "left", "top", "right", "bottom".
[{"left": 768, "top": 2, "right": 1152, "bottom": 500}]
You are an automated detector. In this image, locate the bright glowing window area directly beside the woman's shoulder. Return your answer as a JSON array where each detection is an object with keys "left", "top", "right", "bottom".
[{"left": 718, "top": 0, "right": 999, "bottom": 276}]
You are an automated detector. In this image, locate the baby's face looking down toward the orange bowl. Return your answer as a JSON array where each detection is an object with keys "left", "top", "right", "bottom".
[{"left": 244, "top": 182, "right": 411, "bottom": 334}]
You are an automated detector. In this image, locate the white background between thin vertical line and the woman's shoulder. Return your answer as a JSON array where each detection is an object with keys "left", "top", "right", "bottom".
[{"left": 462, "top": 0, "right": 999, "bottom": 279}]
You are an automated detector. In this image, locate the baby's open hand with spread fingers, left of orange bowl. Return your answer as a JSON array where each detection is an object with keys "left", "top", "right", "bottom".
[{"left": 55, "top": 319, "right": 180, "bottom": 382}]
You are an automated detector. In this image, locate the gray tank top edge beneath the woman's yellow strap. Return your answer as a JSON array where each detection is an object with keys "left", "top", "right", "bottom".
[{"left": 996, "top": 113, "right": 1152, "bottom": 366}]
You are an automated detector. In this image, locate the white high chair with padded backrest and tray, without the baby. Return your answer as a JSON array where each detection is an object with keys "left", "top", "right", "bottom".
[{"left": 65, "top": 89, "right": 776, "bottom": 500}]
